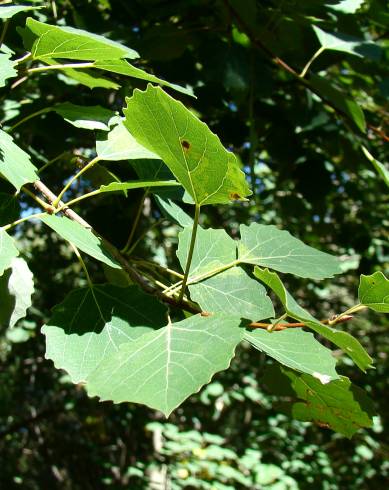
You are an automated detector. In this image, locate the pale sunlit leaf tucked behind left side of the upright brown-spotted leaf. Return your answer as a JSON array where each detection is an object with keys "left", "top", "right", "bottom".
[{"left": 96, "top": 121, "right": 159, "bottom": 161}]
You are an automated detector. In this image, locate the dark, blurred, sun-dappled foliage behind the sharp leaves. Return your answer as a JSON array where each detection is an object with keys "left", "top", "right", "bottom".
[{"left": 0, "top": 0, "right": 389, "bottom": 490}]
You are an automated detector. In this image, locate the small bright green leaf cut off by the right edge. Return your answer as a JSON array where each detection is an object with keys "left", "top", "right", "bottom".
[{"left": 358, "top": 271, "right": 389, "bottom": 313}]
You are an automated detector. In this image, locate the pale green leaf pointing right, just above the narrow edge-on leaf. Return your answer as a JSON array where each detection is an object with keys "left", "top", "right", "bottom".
[{"left": 238, "top": 223, "right": 341, "bottom": 279}]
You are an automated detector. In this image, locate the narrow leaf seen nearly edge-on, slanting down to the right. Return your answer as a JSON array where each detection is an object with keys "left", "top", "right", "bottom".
[{"left": 254, "top": 267, "right": 372, "bottom": 371}]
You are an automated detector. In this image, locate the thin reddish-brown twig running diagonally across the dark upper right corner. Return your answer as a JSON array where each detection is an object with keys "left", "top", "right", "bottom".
[{"left": 224, "top": 0, "right": 389, "bottom": 141}]
